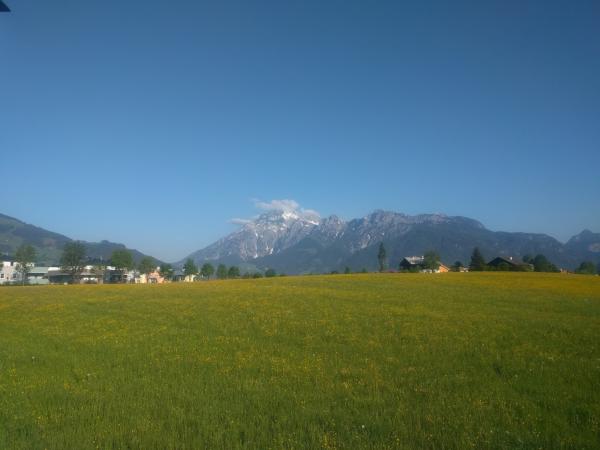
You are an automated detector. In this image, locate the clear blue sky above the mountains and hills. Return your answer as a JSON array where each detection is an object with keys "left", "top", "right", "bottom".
[{"left": 0, "top": 0, "right": 600, "bottom": 260}]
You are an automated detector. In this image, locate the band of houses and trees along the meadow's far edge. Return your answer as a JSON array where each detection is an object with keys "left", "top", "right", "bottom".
[{"left": 0, "top": 242, "right": 596, "bottom": 285}]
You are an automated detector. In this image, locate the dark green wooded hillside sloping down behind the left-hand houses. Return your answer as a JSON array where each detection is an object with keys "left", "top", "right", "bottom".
[{"left": 0, "top": 214, "right": 160, "bottom": 265}]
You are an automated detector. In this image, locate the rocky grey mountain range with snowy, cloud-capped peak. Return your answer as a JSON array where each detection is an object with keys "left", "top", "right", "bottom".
[{"left": 177, "top": 200, "right": 600, "bottom": 274}]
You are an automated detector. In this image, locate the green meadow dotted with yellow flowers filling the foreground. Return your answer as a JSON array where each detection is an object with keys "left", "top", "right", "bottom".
[{"left": 0, "top": 273, "right": 600, "bottom": 449}]
